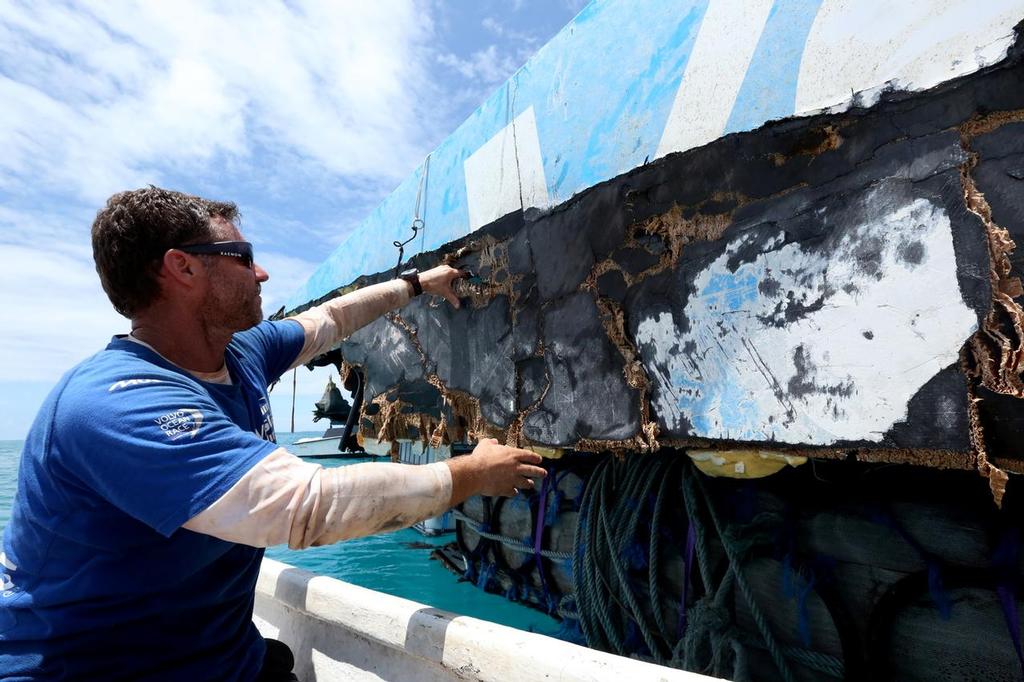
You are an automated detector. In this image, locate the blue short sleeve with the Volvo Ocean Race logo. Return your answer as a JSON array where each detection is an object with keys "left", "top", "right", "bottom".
[{"left": 51, "top": 376, "right": 276, "bottom": 536}]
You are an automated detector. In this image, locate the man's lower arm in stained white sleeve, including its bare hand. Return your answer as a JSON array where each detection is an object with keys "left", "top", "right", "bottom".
[{"left": 184, "top": 438, "right": 545, "bottom": 549}]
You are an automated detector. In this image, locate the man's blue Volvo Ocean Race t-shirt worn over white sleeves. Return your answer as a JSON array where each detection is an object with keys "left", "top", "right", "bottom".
[{"left": 0, "top": 321, "right": 303, "bottom": 681}]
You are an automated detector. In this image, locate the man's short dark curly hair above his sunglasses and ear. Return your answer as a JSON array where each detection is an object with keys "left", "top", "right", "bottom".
[{"left": 92, "top": 185, "right": 239, "bottom": 318}]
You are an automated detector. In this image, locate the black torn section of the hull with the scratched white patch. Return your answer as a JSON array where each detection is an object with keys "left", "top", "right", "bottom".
[{"left": 321, "top": 57, "right": 1024, "bottom": 477}]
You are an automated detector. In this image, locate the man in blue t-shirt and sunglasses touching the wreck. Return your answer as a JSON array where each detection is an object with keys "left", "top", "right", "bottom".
[{"left": 0, "top": 187, "right": 544, "bottom": 680}]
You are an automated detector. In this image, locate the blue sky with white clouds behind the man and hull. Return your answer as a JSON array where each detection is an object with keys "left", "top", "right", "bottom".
[{"left": 0, "top": 0, "right": 586, "bottom": 439}]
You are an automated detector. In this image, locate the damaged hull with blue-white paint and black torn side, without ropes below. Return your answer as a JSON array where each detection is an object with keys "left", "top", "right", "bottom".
[{"left": 284, "top": 0, "right": 1024, "bottom": 477}]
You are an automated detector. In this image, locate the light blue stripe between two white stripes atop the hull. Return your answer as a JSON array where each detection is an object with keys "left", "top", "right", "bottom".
[{"left": 725, "top": 0, "right": 821, "bottom": 133}]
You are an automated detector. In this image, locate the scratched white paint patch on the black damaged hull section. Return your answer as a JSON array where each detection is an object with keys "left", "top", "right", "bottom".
[{"left": 637, "top": 193, "right": 977, "bottom": 445}]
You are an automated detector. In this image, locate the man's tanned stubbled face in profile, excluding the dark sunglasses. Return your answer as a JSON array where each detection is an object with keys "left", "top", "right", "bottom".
[{"left": 202, "top": 218, "right": 269, "bottom": 333}]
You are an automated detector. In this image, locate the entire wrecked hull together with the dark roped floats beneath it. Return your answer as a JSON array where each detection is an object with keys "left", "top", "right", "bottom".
[{"left": 284, "top": 0, "right": 1024, "bottom": 680}]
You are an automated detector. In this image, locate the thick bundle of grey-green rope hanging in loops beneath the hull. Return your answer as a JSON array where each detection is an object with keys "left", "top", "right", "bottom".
[{"left": 572, "top": 453, "right": 847, "bottom": 682}]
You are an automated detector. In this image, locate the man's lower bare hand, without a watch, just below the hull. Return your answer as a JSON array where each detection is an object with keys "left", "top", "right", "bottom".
[{"left": 447, "top": 438, "right": 548, "bottom": 506}]
